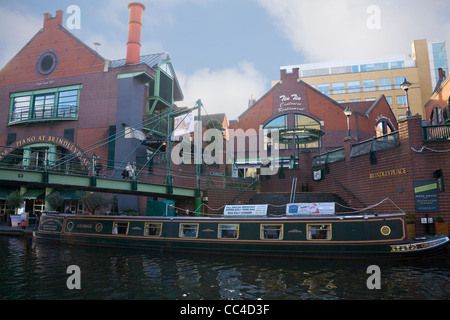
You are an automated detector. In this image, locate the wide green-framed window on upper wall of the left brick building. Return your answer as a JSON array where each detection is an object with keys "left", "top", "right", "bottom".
[{"left": 9, "top": 85, "right": 81, "bottom": 124}]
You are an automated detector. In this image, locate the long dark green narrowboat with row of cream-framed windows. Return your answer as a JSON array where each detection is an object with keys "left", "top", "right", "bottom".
[{"left": 35, "top": 213, "right": 449, "bottom": 259}]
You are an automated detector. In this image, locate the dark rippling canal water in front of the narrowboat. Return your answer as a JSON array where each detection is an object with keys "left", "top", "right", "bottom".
[{"left": 0, "top": 236, "right": 450, "bottom": 301}]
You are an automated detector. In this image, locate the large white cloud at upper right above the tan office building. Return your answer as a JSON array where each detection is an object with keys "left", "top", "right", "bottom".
[{"left": 257, "top": 0, "right": 450, "bottom": 62}]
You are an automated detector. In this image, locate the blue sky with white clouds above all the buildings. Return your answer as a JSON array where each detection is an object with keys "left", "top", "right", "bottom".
[{"left": 0, "top": 0, "right": 450, "bottom": 120}]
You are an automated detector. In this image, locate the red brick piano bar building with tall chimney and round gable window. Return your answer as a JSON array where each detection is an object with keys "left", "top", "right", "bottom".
[{"left": 0, "top": 2, "right": 183, "bottom": 211}]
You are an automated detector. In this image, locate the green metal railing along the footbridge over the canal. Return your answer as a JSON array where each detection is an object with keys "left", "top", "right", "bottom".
[{"left": 0, "top": 146, "right": 255, "bottom": 190}]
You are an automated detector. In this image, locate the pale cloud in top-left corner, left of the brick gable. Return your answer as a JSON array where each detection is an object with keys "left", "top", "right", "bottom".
[{"left": 0, "top": 7, "right": 43, "bottom": 68}]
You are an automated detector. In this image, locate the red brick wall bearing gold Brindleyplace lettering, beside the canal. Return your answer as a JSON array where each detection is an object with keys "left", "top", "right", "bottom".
[{"left": 312, "top": 116, "right": 450, "bottom": 232}]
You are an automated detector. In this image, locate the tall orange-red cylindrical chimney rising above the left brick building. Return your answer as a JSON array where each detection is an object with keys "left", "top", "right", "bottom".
[{"left": 126, "top": 2, "right": 145, "bottom": 64}]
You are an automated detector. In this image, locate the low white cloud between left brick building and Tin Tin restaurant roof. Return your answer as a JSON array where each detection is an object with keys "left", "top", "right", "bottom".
[{"left": 177, "top": 61, "right": 267, "bottom": 120}]
